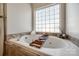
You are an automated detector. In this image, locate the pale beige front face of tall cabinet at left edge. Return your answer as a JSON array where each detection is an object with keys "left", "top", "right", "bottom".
[{"left": 0, "top": 3, "right": 4, "bottom": 56}]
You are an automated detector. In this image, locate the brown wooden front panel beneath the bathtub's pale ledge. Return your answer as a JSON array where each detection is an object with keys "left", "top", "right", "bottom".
[{"left": 6, "top": 42, "right": 47, "bottom": 56}]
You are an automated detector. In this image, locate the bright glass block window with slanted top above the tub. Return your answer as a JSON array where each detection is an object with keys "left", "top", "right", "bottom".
[{"left": 35, "top": 4, "right": 60, "bottom": 33}]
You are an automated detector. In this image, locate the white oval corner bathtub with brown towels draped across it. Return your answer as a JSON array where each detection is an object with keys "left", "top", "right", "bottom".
[{"left": 11, "top": 35, "right": 79, "bottom": 56}]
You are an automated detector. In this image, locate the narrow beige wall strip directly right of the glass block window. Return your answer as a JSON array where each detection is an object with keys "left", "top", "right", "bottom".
[{"left": 59, "top": 3, "right": 66, "bottom": 33}]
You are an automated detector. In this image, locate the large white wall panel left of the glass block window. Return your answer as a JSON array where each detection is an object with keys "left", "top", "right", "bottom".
[{"left": 7, "top": 3, "right": 32, "bottom": 34}]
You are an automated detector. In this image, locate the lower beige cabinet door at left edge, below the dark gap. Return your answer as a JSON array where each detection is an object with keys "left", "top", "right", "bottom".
[{"left": 0, "top": 18, "right": 4, "bottom": 55}]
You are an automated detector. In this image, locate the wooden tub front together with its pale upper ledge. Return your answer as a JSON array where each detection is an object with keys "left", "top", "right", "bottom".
[{"left": 5, "top": 39, "right": 49, "bottom": 56}]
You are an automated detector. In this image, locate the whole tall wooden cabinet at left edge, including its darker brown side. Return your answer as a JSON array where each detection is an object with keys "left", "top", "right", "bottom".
[{"left": 0, "top": 3, "right": 6, "bottom": 56}]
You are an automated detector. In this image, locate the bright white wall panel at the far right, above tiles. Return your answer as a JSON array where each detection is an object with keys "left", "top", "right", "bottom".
[{"left": 66, "top": 3, "right": 79, "bottom": 39}]
